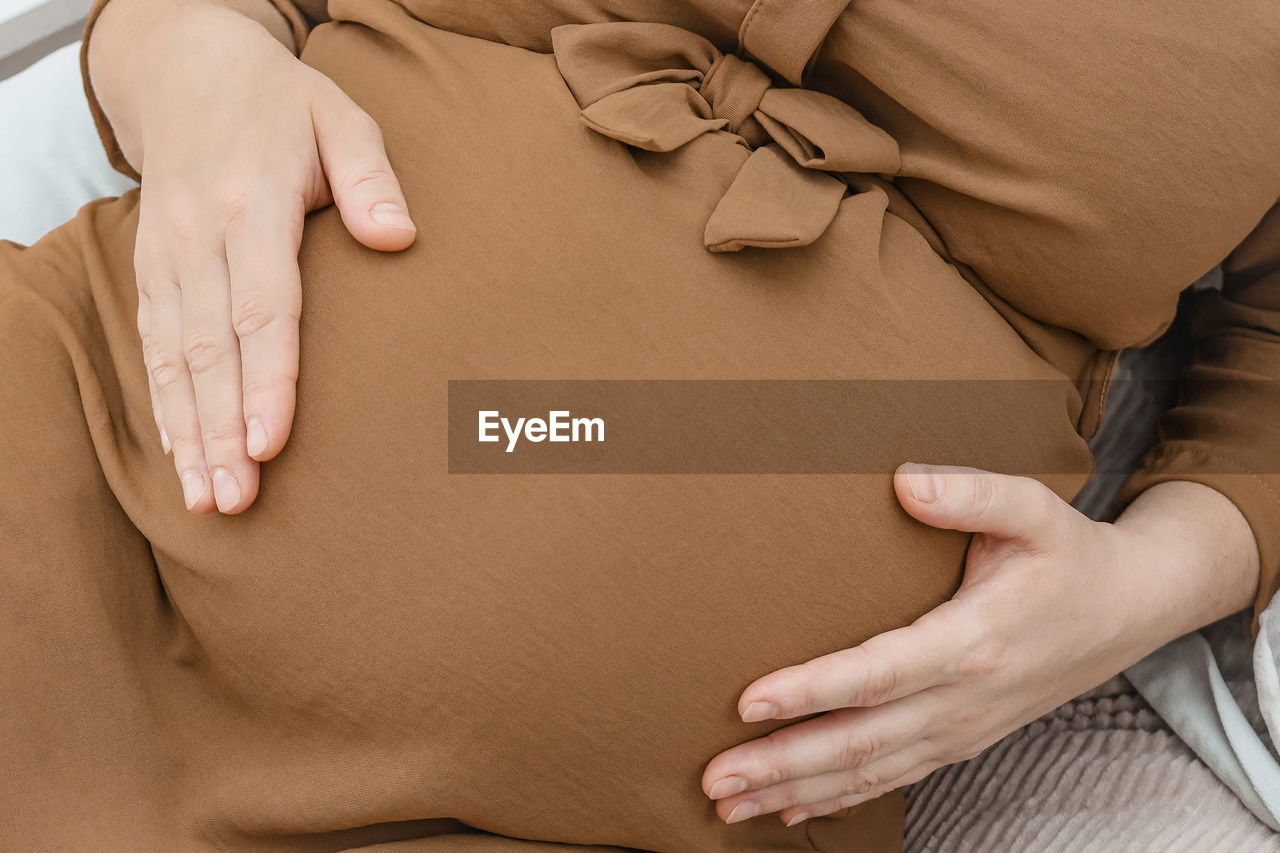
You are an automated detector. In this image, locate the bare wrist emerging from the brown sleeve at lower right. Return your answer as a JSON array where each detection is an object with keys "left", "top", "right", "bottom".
[{"left": 1116, "top": 482, "right": 1260, "bottom": 644}]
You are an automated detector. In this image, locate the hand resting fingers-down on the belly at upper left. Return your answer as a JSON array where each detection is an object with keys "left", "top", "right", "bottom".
[{"left": 90, "top": 0, "right": 416, "bottom": 514}]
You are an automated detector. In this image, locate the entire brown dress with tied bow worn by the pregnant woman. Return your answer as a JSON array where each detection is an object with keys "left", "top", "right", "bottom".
[{"left": 0, "top": 0, "right": 1280, "bottom": 853}]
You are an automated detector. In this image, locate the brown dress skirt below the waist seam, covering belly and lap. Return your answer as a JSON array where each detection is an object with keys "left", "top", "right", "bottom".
[{"left": 10, "top": 3, "right": 1088, "bottom": 852}]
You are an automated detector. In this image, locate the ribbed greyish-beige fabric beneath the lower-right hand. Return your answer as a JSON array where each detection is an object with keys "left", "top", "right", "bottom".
[{"left": 906, "top": 678, "right": 1280, "bottom": 853}]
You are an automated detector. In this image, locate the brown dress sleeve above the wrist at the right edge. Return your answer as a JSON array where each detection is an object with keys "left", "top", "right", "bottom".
[{"left": 1120, "top": 204, "right": 1280, "bottom": 628}]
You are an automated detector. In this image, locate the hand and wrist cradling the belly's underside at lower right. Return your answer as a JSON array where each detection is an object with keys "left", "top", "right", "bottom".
[{"left": 703, "top": 465, "right": 1257, "bottom": 825}]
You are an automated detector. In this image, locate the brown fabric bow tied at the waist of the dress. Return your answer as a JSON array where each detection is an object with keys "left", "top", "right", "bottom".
[{"left": 552, "top": 22, "right": 901, "bottom": 252}]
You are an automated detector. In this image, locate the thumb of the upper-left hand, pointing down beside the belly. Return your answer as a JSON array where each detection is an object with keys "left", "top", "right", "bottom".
[{"left": 311, "top": 92, "right": 417, "bottom": 252}]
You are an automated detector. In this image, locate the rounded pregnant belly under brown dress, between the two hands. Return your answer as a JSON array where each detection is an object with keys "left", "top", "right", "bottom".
[{"left": 140, "top": 13, "right": 1088, "bottom": 850}]
